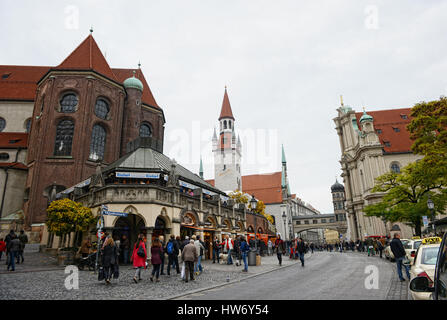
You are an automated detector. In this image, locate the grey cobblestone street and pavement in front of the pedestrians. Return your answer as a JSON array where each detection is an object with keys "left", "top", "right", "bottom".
[{"left": 0, "top": 252, "right": 408, "bottom": 300}]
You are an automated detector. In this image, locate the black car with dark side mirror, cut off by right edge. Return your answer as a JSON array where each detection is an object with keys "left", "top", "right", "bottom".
[{"left": 410, "top": 232, "right": 447, "bottom": 301}]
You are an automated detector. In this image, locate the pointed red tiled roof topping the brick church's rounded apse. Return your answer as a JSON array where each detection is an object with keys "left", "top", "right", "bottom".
[{"left": 54, "top": 34, "right": 118, "bottom": 81}]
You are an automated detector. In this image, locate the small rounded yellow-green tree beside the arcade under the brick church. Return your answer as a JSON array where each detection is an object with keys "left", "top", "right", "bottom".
[{"left": 46, "top": 199, "right": 96, "bottom": 248}]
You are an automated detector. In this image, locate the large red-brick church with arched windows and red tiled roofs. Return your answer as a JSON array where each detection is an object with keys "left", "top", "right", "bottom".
[{"left": 0, "top": 34, "right": 165, "bottom": 240}]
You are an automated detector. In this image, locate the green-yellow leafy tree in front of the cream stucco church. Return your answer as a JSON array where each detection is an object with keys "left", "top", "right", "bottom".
[{"left": 364, "top": 161, "right": 447, "bottom": 236}]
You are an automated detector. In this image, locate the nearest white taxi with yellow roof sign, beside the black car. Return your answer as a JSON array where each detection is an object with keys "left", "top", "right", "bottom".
[{"left": 410, "top": 239, "right": 441, "bottom": 300}]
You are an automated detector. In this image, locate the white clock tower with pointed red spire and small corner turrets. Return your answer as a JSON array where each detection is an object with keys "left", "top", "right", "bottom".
[{"left": 213, "top": 87, "right": 242, "bottom": 192}]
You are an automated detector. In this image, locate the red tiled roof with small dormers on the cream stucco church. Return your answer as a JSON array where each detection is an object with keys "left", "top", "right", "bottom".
[{"left": 355, "top": 108, "right": 413, "bottom": 153}]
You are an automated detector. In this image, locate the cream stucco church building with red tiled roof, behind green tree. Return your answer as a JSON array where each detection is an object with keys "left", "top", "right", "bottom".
[{"left": 333, "top": 102, "right": 421, "bottom": 241}]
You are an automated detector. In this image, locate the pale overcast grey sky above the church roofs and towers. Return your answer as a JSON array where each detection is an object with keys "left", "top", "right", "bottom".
[{"left": 0, "top": 0, "right": 447, "bottom": 213}]
